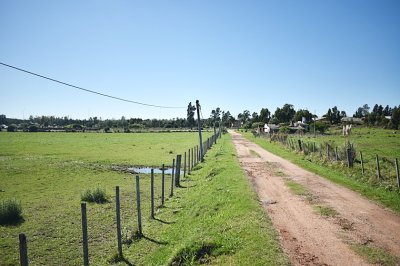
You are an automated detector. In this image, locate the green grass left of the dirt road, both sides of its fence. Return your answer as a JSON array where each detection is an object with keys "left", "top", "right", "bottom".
[{"left": 0, "top": 133, "right": 288, "bottom": 265}]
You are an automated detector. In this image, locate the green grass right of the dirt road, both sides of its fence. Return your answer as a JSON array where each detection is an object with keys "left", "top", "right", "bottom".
[{"left": 242, "top": 128, "right": 400, "bottom": 213}]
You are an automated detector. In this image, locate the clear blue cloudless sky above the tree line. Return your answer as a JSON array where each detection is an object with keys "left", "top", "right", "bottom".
[{"left": 0, "top": 0, "right": 400, "bottom": 119}]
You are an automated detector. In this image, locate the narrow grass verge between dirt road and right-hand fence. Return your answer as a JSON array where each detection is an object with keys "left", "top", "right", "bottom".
[{"left": 242, "top": 133, "right": 400, "bottom": 214}]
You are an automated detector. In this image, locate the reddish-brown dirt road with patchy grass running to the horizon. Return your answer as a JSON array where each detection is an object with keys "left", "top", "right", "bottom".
[{"left": 230, "top": 131, "right": 400, "bottom": 265}]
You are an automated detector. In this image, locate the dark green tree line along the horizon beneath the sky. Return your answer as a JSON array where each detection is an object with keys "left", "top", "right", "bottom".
[{"left": 0, "top": 102, "right": 400, "bottom": 132}]
